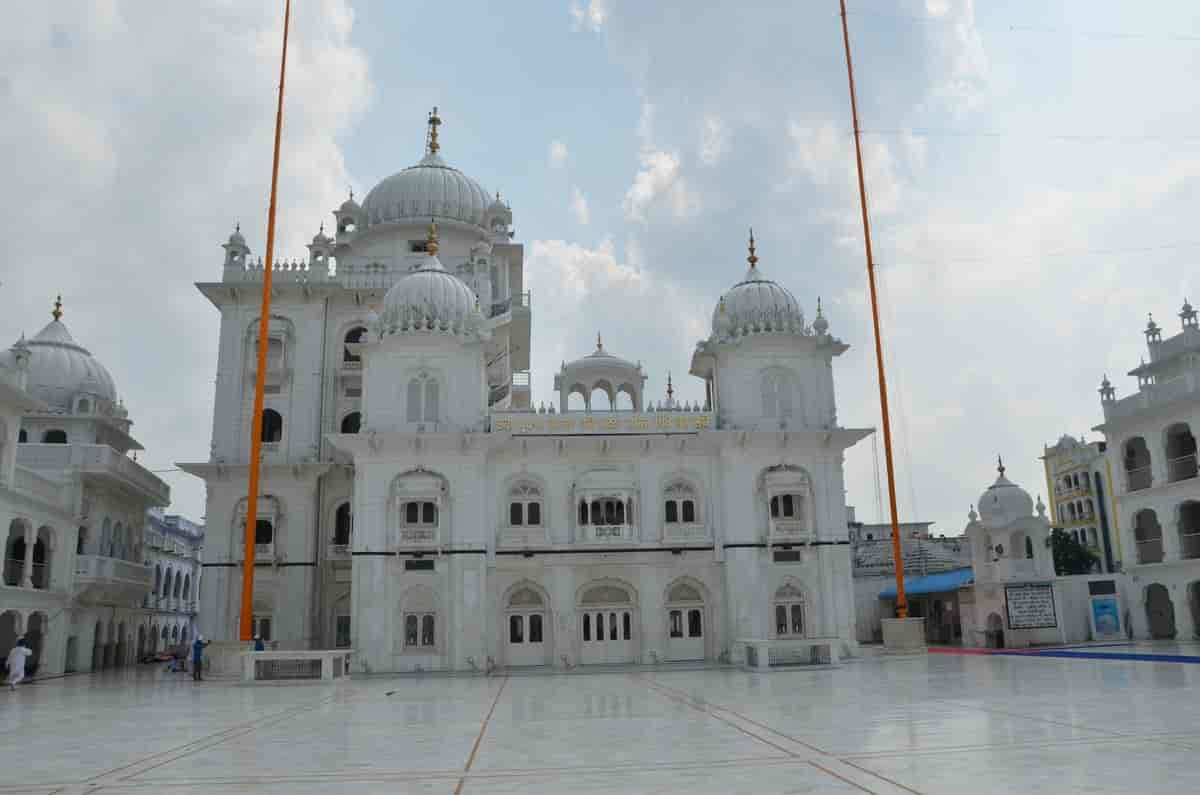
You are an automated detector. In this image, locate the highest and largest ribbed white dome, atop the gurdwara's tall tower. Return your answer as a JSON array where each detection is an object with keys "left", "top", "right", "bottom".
[{"left": 362, "top": 153, "right": 491, "bottom": 226}]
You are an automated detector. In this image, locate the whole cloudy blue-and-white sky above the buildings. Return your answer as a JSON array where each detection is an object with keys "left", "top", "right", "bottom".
[{"left": 0, "top": 0, "right": 1200, "bottom": 532}]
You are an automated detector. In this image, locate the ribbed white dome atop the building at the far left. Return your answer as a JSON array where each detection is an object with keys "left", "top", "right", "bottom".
[{"left": 19, "top": 319, "right": 116, "bottom": 411}]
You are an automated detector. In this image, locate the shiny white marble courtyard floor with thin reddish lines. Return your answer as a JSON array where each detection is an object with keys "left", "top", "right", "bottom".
[{"left": 0, "top": 644, "right": 1200, "bottom": 795}]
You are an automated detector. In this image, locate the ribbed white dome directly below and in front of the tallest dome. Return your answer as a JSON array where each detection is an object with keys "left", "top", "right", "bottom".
[{"left": 380, "top": 253, "right": 480, "bottom": 334}]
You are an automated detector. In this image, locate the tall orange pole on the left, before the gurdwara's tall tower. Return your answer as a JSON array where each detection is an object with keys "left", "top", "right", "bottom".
[{"left": 238, "top": 0, "right": 292, "bottom": 640}]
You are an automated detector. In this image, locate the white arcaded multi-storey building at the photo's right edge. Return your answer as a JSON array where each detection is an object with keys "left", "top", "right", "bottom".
[{"left": 1094, "top": 301, "right": 1200, "bottom": 639}]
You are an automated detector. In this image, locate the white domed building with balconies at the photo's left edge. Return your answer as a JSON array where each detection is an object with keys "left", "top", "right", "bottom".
[{"left": 0, "top": 301, "right": 186, "bottom": 676}]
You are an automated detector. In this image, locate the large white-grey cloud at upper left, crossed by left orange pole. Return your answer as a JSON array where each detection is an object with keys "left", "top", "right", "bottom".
[{"left": 0, "top": 0, "right": 371, "bottom": 519}]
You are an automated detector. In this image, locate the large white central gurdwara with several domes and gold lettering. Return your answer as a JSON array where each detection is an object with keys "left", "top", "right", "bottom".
[{"left": 181, "top": 114, "right": 869, "bottom": 673}]
